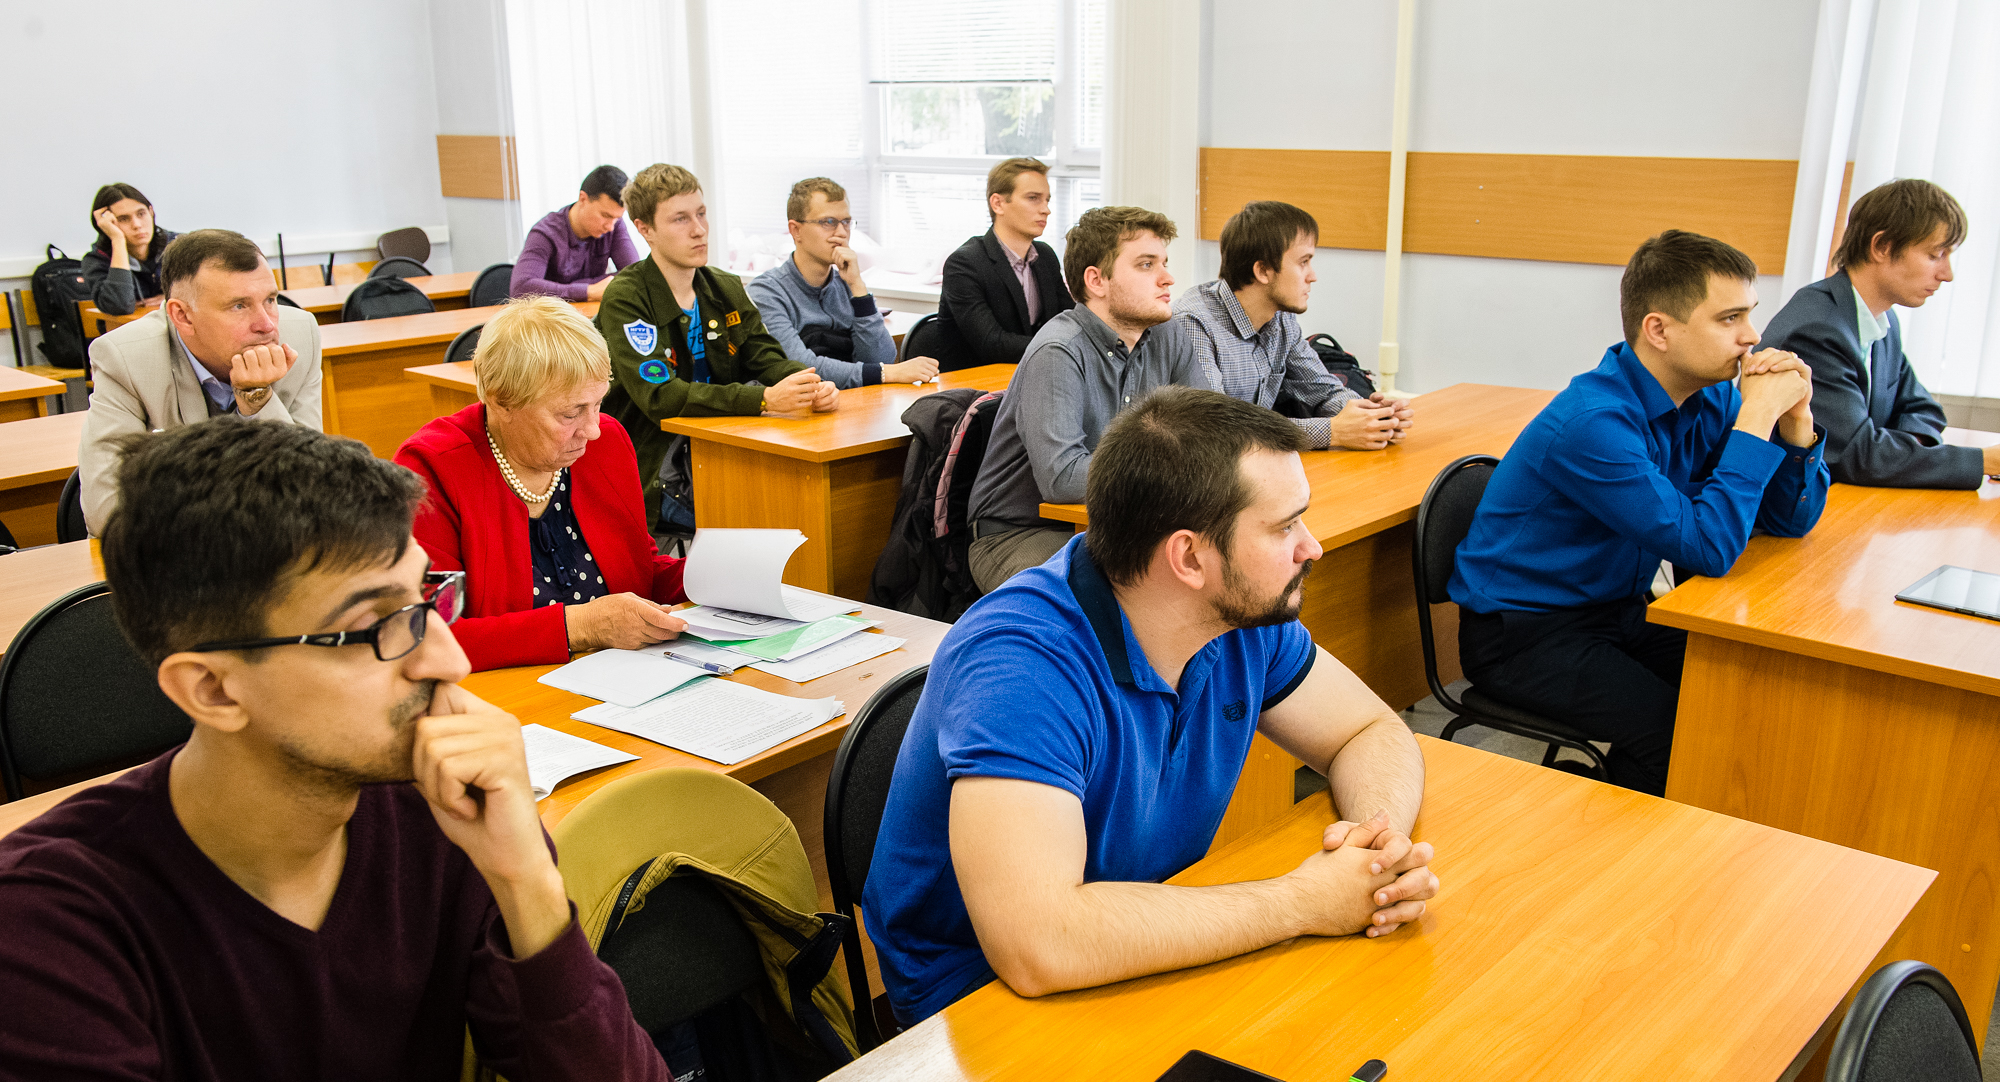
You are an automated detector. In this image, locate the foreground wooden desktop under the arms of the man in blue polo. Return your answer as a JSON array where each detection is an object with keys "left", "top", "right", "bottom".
[{"left": 832, "top": 738, "right": 1932, "bottom": 1082}]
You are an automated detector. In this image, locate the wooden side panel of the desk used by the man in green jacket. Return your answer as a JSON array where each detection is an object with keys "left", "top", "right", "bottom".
[{"left": 688, "top": 440, "right": 836, "bottom": 598}]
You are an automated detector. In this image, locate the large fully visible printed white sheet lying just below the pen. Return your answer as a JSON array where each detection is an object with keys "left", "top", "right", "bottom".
[{"left": 570, "top": 680, "right": 846, "bottom": 766}]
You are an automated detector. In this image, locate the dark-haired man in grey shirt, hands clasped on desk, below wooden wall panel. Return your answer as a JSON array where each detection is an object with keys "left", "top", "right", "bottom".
[{"left": 1174, "top": 200, "right": 1416, "bottom": 450}]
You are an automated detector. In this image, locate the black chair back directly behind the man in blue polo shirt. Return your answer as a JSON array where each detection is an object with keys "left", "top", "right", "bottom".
[{"left": 824, "top": 664, "right": 930, "bottom": 1052}]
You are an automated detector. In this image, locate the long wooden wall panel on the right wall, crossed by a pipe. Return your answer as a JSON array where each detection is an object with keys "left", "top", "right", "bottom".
[{"left": 1202, "top": 148, "right": 1798, "bottom": 274}]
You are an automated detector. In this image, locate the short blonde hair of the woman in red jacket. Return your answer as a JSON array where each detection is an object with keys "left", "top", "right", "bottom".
[{"left": 472, "top": 296, "right": 612, "bottom": 410}]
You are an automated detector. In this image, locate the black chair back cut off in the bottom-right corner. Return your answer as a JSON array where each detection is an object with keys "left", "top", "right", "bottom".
[{"left": 1826, "top": 962, "right": 1980, "bottom": 1082}]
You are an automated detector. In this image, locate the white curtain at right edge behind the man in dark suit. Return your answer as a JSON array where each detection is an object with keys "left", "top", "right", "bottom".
[{"left": 1784, "top": 0, "right": 2000, "bottom": 398}]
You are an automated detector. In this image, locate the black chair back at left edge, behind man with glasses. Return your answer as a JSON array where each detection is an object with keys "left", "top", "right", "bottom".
[{"left": 0, "top": 582, "right": 194, "bottom": 800}]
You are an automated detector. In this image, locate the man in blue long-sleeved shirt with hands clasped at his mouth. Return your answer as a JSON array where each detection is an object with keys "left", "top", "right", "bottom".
[{"left": 1450, "top": 230, "right": 1828, "bottom": 796}]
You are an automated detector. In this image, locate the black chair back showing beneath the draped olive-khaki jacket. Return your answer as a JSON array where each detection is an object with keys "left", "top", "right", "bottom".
[{"left": 598, "top": 864, "right": 764, "bottom": 1034}]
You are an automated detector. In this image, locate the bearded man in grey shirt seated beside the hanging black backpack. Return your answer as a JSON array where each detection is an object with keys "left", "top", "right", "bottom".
[{"left": 972, "top": 206, "right": 1210, "bottom": 592}]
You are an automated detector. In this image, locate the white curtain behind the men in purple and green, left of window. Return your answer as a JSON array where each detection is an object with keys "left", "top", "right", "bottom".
[{"left": 506, "top": 0, "right": 696, "bottom": 240}]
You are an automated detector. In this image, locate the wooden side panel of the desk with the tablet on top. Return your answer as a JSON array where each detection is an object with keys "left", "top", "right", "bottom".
[{"left": 1666, "top": 634, "right": 2000, "bottom": 1042}]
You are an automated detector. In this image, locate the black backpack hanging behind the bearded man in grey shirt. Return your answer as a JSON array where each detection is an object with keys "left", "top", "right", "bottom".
[{"left": 868, "top": 388, "right": 1002, "bottom": 622}]
